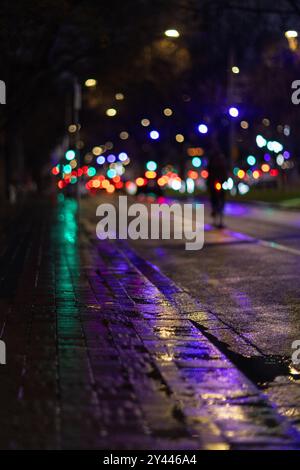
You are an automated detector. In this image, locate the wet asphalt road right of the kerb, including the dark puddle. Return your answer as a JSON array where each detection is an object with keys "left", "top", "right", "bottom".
[{"left": 96, "top": 196, "right": 300, "bottom": 426}]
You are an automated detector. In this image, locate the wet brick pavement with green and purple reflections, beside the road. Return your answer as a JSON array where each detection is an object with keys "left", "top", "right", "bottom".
[{"left": 0, "top": 200, "right": 300, "bottom": 449}]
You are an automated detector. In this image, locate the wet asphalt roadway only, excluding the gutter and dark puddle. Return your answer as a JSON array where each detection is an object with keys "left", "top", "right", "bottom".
[{"left": 132, "top": 203, "right": 300, "bottom": 357}]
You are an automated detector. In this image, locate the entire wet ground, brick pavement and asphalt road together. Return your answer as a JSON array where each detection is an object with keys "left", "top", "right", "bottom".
[{"left": 0, "top": 199, "right": 300, "bottom": 449}]
